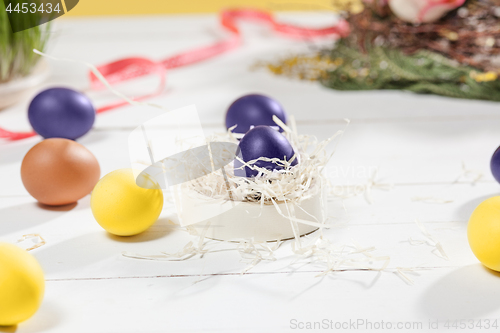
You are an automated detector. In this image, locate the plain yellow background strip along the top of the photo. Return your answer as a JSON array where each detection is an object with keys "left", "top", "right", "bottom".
[{"left": 66, "top": 0, "right": 345, "bottom": 16}]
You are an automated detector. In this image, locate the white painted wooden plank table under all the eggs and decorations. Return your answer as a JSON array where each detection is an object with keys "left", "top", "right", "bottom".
[{"left": 0, "top": 13, "right": 500, "bottom": 333}]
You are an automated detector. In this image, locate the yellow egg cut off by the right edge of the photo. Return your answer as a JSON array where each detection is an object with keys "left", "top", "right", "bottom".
[{"left": 467, "top": 197, "right": 500, "bottom": 271}]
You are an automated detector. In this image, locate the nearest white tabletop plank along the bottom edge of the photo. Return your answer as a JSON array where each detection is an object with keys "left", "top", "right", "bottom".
[{"left": 13, "top": 265, "right": 500, "bottom": 333}]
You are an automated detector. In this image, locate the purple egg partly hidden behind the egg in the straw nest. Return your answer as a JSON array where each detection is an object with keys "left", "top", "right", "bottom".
[{"left": 226, "top": 94, "right": 286, "bottom": 134}]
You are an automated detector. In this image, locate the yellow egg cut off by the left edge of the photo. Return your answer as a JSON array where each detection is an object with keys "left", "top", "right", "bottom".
[{"left": 0, "top": 243, "right": 45, "bottom": 326}]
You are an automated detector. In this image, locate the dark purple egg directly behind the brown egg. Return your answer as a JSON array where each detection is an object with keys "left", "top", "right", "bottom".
[{"left": 28, "top": 88, "right": 95, "bottom": 140}]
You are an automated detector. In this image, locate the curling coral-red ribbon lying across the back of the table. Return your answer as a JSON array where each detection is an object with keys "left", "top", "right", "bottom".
[{"left": 0, "top": 9, "right": 350, "bottom": 141}]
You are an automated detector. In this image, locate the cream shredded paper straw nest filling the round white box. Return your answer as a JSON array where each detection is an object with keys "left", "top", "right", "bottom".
[{"left": 189, "top": 117, "right": 342, "bottom": 218}]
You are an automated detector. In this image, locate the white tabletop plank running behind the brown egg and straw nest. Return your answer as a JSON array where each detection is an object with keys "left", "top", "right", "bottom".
[{"left": 0, "top": 116, "right": 500, "bottom": 196}]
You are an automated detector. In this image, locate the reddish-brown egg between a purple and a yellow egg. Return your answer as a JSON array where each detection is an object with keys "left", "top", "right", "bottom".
[{"left": 21, "top": 138, "right": 101, "bottom": 206}]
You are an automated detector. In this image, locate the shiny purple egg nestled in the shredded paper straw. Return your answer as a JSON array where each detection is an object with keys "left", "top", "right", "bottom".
[{"left": 234, "top": 125, "right": 297, "bottom": 177}]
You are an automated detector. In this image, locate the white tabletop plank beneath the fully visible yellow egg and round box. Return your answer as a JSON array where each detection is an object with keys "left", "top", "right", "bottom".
[{"left": 0, "top": 184, "right": 488, "bottom": 279}]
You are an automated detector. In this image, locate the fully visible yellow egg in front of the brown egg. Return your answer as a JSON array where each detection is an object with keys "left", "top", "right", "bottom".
[{"left": 90, "top": 169, "right": 163, "bottom": 236}]
